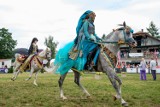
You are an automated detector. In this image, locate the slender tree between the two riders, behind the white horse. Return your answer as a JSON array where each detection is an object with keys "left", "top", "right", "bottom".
[{"left": 44, "top": 36, "right": 58, "bottom": 58}]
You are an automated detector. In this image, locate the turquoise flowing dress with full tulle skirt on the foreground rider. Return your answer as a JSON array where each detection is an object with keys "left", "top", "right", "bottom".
[{"left": 54, "top": 10, "right": 101, "bottom": 75}]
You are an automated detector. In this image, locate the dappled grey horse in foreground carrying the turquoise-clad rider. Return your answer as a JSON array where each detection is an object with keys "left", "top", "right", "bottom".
[{"left": 55, "top": 22, "right": 136, "bottom": 106}]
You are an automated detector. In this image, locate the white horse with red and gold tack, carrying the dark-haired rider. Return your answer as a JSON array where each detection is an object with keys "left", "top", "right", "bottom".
[{"left": 11, "top": 48, "right": 51, "bottom": 86}]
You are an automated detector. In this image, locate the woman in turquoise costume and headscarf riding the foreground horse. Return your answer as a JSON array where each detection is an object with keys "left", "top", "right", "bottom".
[{"left": 54, "top": 10, "right": 101, "bottom": 75}]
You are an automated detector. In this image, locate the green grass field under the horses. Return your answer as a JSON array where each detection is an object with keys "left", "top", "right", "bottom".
[{"left": 0, "top": 73, "right": 160, "bottom": 107}]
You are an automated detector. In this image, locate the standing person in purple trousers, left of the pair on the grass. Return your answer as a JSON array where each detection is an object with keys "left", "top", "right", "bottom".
[{"left": 139, "top": 58, "right": 147, "bottom": 80}]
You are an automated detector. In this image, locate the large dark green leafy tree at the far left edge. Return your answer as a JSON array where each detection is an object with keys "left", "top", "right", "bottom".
[{"left": 0, "top": 28, "right": 17, "bottom": 59}]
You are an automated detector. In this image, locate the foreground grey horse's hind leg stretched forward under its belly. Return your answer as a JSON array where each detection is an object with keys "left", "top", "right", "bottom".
[{"left": 73, "top": 70, "right": 90, "bottom": 98}]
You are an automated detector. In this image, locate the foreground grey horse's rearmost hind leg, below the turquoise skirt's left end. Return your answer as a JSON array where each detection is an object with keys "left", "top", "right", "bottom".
[{"left": 58, "top": 73, "right": 67, "bottom": 100}]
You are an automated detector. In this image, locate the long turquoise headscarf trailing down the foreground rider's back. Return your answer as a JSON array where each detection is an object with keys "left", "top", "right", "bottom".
[{"left": 74, "top": 10, "right": 93, "bottom": 43}]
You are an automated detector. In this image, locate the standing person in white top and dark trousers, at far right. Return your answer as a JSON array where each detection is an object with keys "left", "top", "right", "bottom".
[{"left": 150, "top": 58, "right": 156, "bottom": 80}]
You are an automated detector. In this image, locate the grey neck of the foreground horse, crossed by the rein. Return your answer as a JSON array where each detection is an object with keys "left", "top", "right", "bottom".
[{"left": 105, "top": 32, "right": 119, "bottom": 55}]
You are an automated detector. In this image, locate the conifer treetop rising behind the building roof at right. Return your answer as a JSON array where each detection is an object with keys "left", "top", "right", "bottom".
[{"left": 146, "top": 21, "right": 159, "bottom": 37}]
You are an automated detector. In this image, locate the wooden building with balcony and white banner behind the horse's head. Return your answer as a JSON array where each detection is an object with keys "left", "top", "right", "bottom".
[{"left": 120, "top": 30, "right": 160, "bottom": 66}]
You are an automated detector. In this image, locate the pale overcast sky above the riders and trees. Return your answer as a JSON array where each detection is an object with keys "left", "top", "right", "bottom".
[{"left": 0, "top": 0, "right": 160, "bottom": 49}]
